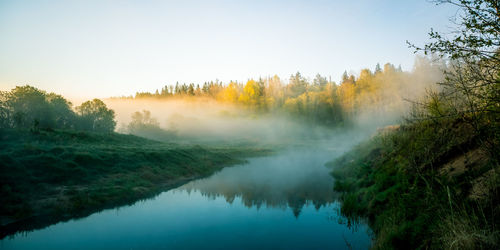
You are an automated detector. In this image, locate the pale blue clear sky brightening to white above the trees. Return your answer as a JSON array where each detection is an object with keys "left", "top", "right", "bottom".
[{"left": 0, "top": 0, "right": 455, "bottom": 99}]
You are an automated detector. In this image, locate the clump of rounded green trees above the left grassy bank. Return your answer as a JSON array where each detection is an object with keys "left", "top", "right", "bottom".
[{"left": 0, "top": 85, "right": 116, "bottom": 132}]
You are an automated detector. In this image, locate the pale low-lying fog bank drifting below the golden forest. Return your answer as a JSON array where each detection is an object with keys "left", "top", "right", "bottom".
[{"left": 105, "top": 96, "right": 397, "bottom": 144}]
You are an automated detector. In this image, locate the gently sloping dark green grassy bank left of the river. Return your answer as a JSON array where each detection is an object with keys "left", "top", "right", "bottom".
[{"left": 0, "top": 130, "right": 268, "bottom": 238}]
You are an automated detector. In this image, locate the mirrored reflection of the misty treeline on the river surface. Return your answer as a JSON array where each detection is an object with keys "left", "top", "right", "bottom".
[{"left": 179, "top": 151, "right": 334, "bottom": 217}]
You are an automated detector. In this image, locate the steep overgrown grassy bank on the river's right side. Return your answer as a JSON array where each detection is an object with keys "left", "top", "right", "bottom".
[{"left": 329, "top": 120, "right": 500, "bottom": 249}]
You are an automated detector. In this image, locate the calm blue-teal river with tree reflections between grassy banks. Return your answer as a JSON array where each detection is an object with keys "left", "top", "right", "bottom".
[{"left": 0, "top": 144, "right": 371, "bottom": 249}]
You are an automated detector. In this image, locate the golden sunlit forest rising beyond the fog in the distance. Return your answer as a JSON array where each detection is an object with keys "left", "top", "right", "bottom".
[{"left": 120, "top": 57, "right": 445, "bottom": 125}]
